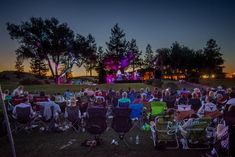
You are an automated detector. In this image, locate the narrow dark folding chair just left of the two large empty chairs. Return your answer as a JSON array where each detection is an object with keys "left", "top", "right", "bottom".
[{"left": 65, "top": 106, "right": 83, "bottom": 132}]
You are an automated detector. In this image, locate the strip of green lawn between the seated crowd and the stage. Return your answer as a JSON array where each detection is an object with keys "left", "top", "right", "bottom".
[{"left": 0, "top": 79, "right": 235, "bottom": 94}]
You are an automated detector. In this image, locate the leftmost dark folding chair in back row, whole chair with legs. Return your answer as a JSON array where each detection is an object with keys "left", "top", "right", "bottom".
[{"left": 13, "top": 107, "right": 34, "bottom": 133}]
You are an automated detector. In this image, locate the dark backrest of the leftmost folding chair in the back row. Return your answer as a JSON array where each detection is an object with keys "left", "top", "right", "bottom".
[{"left": 16, "top": 107, "right": 30, "bottom": 124}]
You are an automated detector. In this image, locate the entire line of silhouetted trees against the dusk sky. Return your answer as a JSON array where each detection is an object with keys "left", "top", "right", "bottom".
[{"left": 7, "top": 17, "right": 224, "bottom": 83}]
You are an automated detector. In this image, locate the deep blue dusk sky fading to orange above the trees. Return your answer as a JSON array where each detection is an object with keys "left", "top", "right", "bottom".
[{"left": 0, "top": 0, "right": 235, "bottom": 73}]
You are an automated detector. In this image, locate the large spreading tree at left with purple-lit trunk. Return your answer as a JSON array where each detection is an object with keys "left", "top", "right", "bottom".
[{"left": 7, "top": 17, "right": 96, "bottom": 83}]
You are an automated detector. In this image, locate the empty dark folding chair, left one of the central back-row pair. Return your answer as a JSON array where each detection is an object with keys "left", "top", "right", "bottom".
[{"left": 85, "top": 108, "right": 107, "bottom": 140}]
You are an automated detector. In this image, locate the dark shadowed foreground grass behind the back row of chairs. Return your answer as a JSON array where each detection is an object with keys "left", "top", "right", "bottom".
[{"left": 0, "top": 126, "right": 204, "bottom": 157}]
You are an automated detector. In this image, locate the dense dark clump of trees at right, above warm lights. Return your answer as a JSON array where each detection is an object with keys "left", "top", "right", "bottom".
[{"left": 156, "top": 39, "right": 224, "bottom": 76}]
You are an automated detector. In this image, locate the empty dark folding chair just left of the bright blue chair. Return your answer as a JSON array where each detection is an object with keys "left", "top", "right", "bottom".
[{"left": 111, "top": 108, "right": 132, "bottom": 146}]
